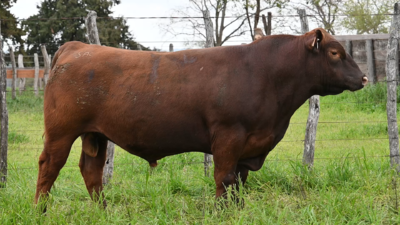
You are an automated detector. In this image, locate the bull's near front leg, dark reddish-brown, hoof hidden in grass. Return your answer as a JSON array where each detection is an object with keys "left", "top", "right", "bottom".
[{"left": 211, "top": 130, "right": 247, "bottom": 204}]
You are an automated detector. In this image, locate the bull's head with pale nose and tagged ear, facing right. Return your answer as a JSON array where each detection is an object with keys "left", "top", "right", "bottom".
[{"left": 305, "top": 28, "right": 368, "bottom": 95}]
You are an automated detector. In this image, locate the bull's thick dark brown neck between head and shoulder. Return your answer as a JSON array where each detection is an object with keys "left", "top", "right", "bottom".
[{"left": 248, "top": 36, "right": 316, "bottom": 117}]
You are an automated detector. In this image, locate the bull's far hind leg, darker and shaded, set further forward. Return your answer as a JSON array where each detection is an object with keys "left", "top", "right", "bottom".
[{"left": 79, "top": 133, "right": 108, "bottom": 207}]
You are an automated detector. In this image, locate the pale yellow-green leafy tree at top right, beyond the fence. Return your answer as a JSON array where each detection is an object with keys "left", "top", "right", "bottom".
[{"left": 341, "top": 0, "right": 397, "bottom": 34}]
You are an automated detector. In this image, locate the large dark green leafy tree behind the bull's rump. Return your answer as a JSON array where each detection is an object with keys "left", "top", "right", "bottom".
[{"left": 23, "top": 0, "right": 149, "bottom": 54}]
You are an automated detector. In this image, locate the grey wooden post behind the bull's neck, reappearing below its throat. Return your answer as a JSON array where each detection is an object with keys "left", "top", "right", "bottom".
[{"left": 297, "top": 9, "right": 319, "bottom": 168}]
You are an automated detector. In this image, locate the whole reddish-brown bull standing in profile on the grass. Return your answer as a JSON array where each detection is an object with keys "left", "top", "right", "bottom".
[{"left": 36, "top": 29, "right": 366, "bottom": 207}]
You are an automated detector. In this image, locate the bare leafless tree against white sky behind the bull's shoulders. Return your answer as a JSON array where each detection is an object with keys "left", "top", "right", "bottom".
[{"left": 163, "top": 0, "right": 287, "bottom": 46}]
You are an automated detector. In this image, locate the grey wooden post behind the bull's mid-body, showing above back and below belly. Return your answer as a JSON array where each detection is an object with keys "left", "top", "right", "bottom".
[{"left": 202, "top": 9, "right": 214, "bottom": 177}]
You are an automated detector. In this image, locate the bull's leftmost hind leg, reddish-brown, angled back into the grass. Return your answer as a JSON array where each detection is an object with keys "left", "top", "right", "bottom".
[{"left": 35, "top": 136, "right": 75, "bottom": 212}]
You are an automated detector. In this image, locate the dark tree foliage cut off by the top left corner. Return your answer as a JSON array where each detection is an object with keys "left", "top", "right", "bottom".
[{"left": 0, "top": 0, "right": 25, "bottom": 53}]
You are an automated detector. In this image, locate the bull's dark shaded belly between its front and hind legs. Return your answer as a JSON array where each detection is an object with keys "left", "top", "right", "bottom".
[{"left": 99, "top": 118, "right": 211, "bottom": 162}]
